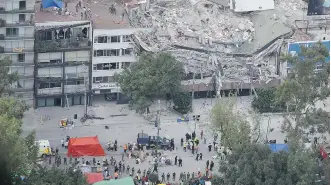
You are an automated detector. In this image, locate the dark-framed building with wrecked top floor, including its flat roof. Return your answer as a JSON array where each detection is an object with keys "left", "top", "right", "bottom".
[{"left": 34, "top": 1, "right": 92, "bottom": 107}]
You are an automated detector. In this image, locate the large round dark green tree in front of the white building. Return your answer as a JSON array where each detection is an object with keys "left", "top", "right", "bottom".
[{"left": 117, "top": 53, "right": 184, "bottom": 113}]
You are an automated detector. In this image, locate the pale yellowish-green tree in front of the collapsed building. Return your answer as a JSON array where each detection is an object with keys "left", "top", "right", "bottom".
[{"left": 211, "top": 98, "right": 251, "bottom": 147}]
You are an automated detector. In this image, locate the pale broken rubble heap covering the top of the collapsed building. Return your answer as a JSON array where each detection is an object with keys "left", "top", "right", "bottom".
[{"left": 131, "top": 0, "right": 254, "bottom": 49}]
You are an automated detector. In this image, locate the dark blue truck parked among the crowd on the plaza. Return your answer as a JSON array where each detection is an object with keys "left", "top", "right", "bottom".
[{"left": 137, "top": 133, "right": 171, "bottom": 150}]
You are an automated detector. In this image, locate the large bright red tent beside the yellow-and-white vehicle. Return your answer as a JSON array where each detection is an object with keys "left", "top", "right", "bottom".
[{"left": 67, "top": 136, "right": 105, "bottom": 157}]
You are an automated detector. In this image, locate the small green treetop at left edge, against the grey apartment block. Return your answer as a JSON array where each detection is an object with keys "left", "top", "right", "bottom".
[{"left": 0, "top": 57, "right": 18, "bottom": 95}]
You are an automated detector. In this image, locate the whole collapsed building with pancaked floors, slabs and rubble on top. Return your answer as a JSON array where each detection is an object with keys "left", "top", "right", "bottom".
[{"left": 124, "top": 0, "right": 292, "bottom": 95}]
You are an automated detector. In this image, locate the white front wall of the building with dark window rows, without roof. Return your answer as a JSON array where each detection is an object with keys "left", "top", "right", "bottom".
[{"left": 92, "top": 28, "right": 138, "bottom": 101}]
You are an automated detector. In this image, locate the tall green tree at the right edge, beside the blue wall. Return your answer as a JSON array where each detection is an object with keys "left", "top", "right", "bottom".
[{"left": 276, "top": 43, "right": 330, "bottom": 140}]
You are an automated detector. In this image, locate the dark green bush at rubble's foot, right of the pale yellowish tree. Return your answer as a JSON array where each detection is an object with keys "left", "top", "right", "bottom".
[{"left": 252, "top": 87, "right": 286, "bottom": 113}]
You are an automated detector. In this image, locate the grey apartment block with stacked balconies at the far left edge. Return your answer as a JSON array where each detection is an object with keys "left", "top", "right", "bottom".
[{"left": 0, "top": 0, "right": 35, "bottom": 105}]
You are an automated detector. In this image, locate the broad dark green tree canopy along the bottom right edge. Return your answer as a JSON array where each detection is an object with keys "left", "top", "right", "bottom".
[{"left": 215, "top": 144, "right": 318, "bottom": 185}]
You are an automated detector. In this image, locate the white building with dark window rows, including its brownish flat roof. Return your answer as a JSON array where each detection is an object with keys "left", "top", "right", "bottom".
[{"left": 90, "top": 1, "right": 148, "bottom": 100}]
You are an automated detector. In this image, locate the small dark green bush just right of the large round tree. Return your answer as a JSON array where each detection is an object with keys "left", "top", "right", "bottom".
[{"left": 172, "top": 92, "right": 192, "bottom": 114}]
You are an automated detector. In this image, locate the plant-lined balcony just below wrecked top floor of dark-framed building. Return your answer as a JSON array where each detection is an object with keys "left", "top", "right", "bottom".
[{"left": 35, "top": 37, "right": 91, "bottom": 53}]
